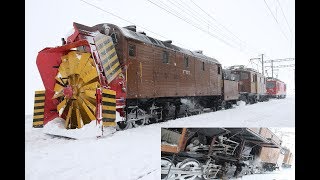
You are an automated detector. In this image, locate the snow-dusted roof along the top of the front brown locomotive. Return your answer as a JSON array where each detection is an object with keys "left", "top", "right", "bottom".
[{"left": 117, "top": 26, "right": 220, "bottom": 64}]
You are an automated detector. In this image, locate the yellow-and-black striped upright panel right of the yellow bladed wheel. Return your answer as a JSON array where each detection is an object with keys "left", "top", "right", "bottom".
[{"left": 102, "top": 89, "right": 116, "bottom": 126}]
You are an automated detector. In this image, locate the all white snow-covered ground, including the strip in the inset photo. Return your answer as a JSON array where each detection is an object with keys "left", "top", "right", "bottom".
[{"left": 25, "top": 96, "right": 295, "bottom": 180}]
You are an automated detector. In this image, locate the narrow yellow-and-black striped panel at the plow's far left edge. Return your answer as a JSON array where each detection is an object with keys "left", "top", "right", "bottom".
[{"left": 33, "top": 91, "right": 45, "bottom": 128}]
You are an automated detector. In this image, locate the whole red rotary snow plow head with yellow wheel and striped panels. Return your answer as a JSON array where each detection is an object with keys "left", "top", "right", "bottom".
[{"left": 33, "top": 23, "right": 125, "bottom": 136}]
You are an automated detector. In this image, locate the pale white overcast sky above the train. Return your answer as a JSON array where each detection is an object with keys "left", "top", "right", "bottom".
[{"left": 25, "top": 0, "right": 295, "bottom": 114}]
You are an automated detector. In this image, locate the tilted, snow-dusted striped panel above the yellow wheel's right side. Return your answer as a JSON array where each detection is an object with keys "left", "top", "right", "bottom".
[{"left": 94, "top": 34, "right": 121, "bottom": 83}]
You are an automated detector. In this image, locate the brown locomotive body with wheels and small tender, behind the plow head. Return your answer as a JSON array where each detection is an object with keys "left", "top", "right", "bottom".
[{"left": 93, "top": 24, "right": 239, "bottom": 129}]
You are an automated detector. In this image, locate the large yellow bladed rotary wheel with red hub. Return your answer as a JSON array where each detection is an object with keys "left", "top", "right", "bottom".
[{"left": 52, "top": 51, "right": 100, "bottom": 129}]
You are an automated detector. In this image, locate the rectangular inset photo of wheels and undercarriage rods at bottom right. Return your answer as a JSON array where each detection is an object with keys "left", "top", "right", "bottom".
[{"left": 161, "top": 127, "right": 295, "bottom": 180}]
